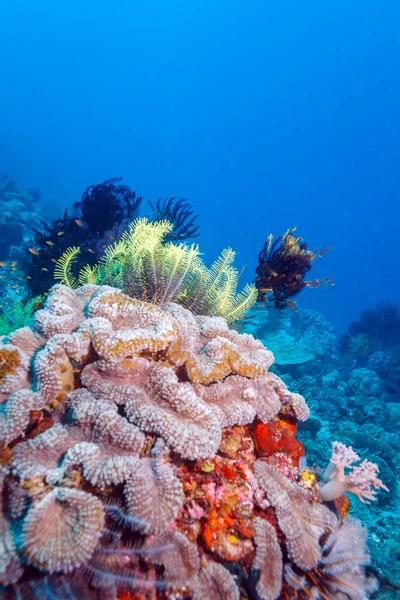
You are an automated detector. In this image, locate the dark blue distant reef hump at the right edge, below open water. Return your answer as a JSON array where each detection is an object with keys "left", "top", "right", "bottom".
[{"left": 349, "top": 300, "right": 400, "bottom": 345}]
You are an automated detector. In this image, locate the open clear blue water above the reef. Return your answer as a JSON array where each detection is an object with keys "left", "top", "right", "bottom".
[{"left": 0, "top": 0, "right": 400, "bottom": 331}]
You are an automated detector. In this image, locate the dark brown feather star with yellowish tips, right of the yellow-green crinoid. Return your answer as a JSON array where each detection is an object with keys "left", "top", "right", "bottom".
[{"left": 255, "top": 229, "right": 333, "bottom": 309}]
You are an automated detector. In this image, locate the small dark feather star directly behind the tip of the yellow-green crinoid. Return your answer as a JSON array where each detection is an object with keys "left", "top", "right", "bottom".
[{"left": 149, "top": 198, "right": 199, "bottom": 242}]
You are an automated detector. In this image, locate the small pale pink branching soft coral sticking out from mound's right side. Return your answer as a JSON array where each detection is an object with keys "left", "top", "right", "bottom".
[{"left": 320, "top": 442, "right": 389, "bottom": 504}]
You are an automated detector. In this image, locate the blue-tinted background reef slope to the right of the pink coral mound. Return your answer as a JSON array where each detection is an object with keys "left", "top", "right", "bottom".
[{"left": 238, "top": 302, "right": 400, "bottom": 600}]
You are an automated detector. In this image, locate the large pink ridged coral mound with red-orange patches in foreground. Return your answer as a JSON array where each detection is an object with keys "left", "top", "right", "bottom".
[{"left": 0, "top": 220, "right": 384, "bottom": 600}]
